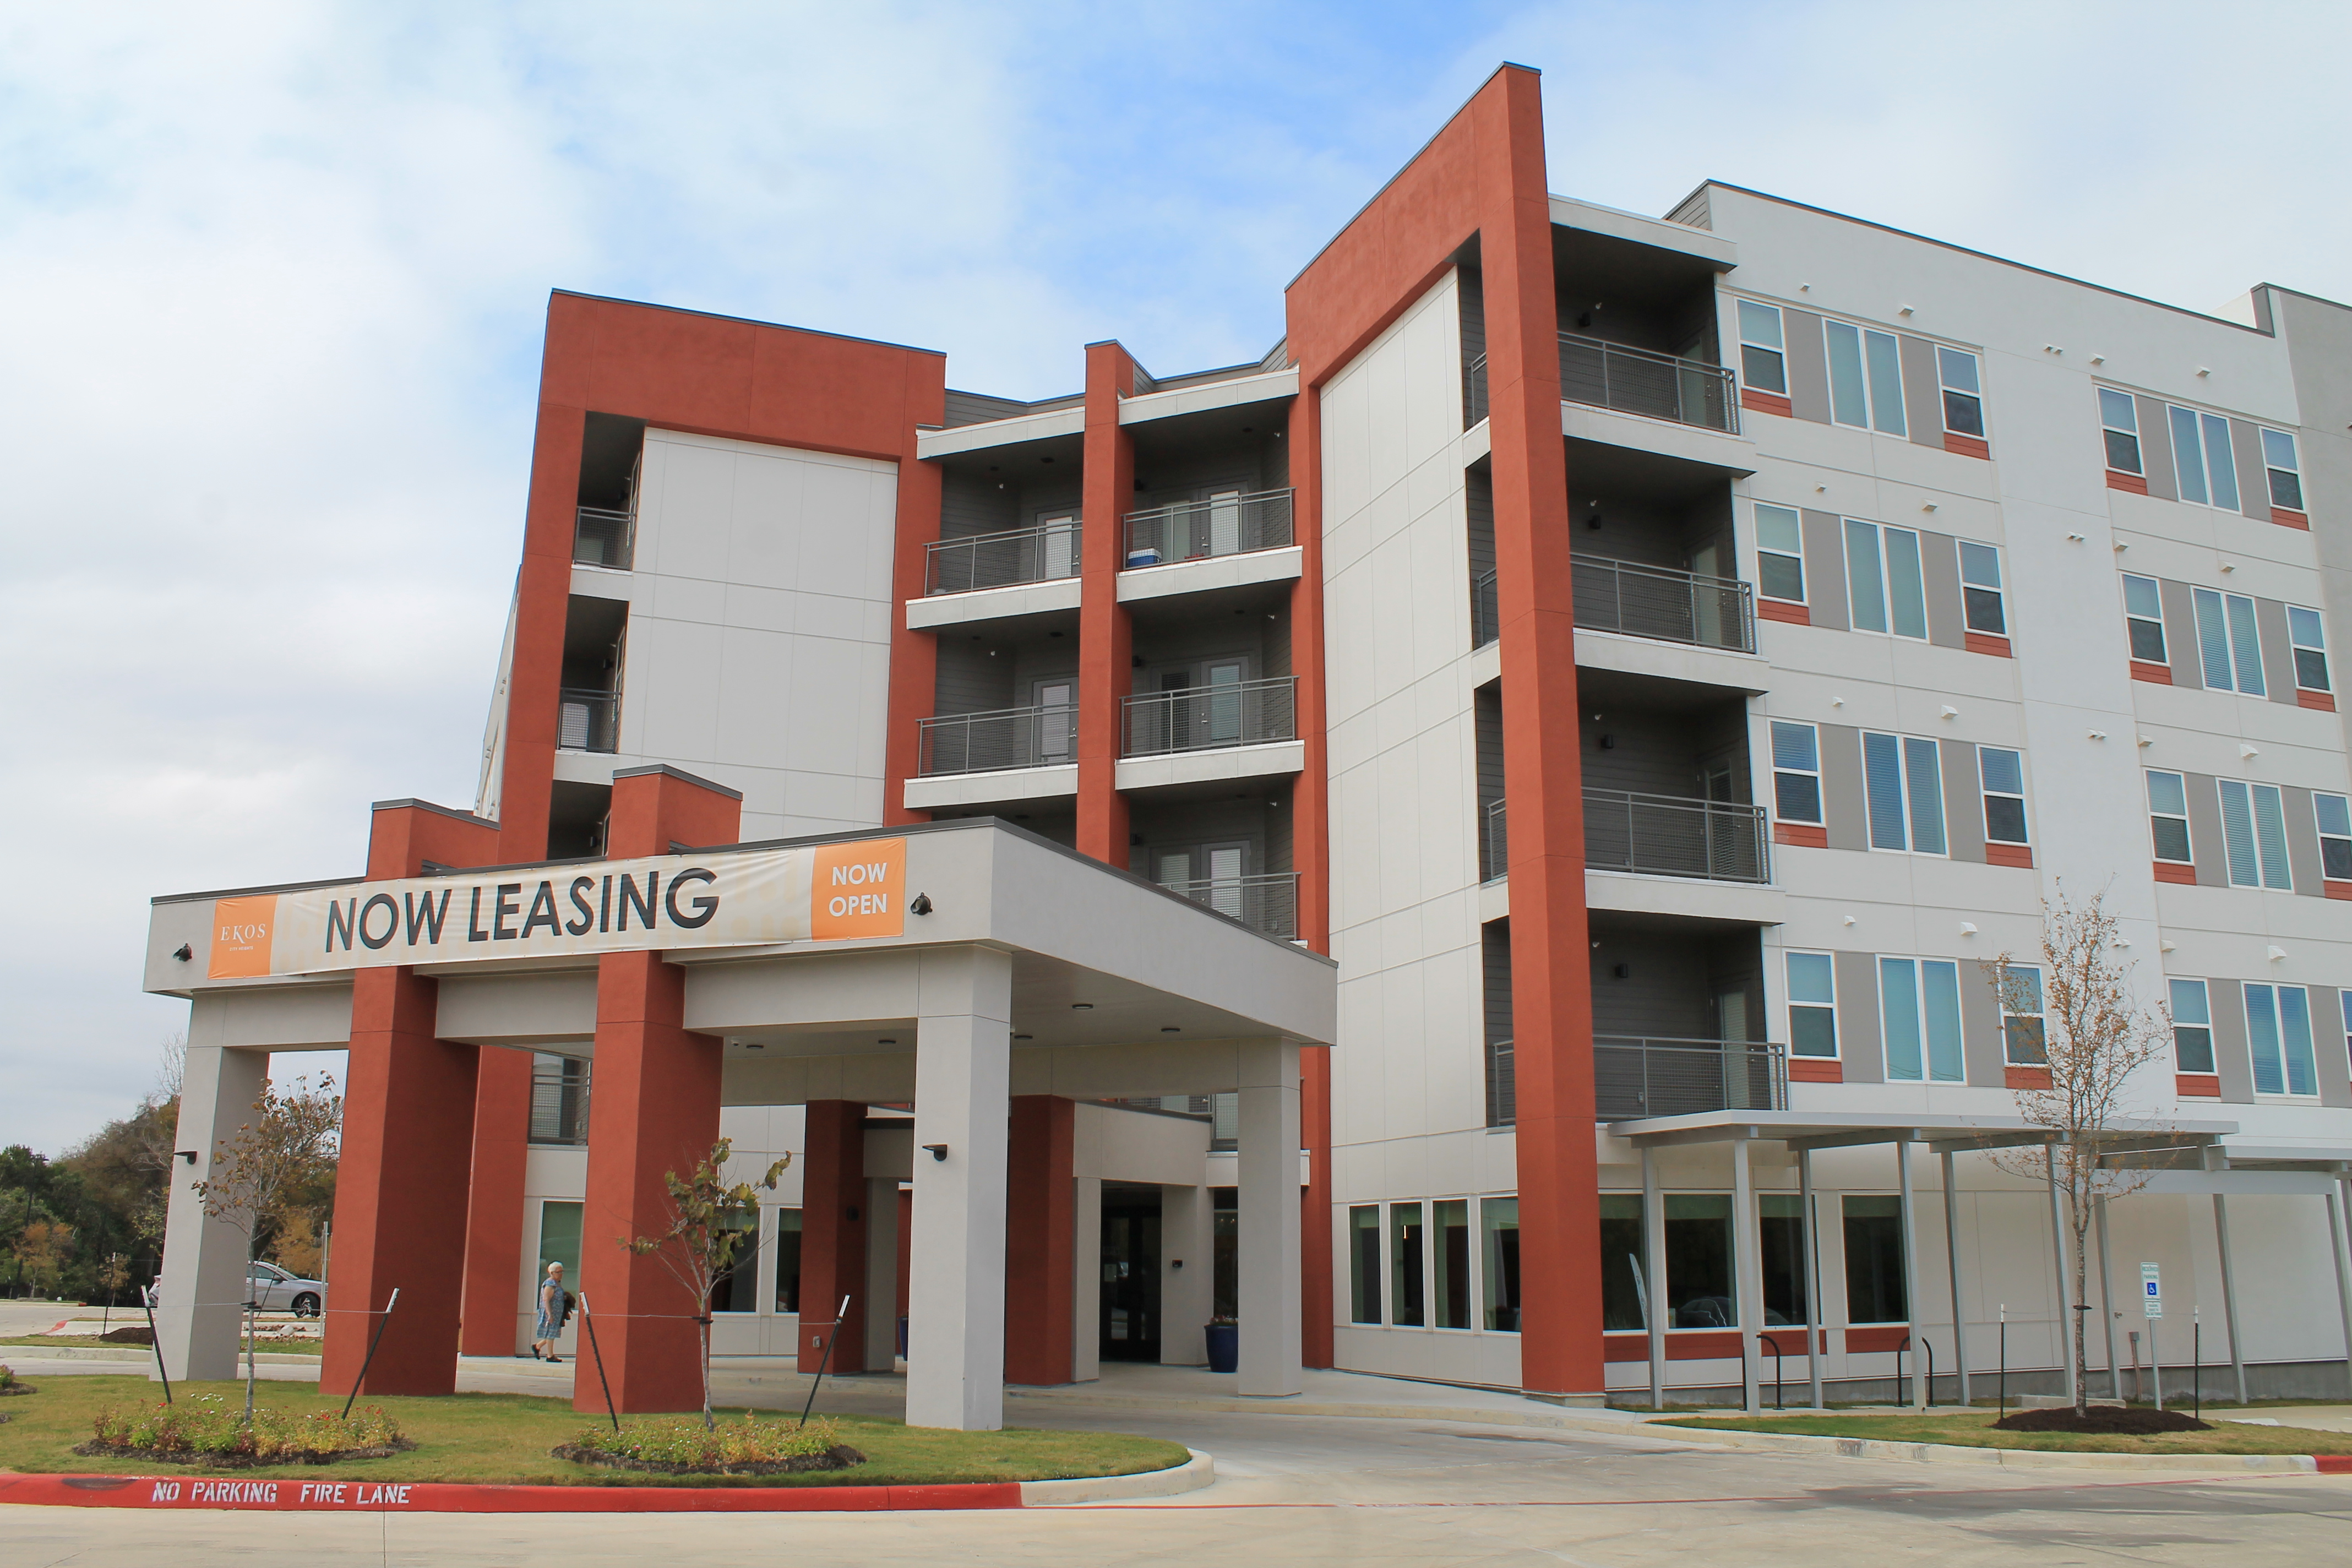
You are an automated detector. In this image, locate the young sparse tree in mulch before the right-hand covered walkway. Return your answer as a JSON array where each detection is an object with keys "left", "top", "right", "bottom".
[{"left": 1983, "top": 881, "right": 2173, "bottom": 1415}]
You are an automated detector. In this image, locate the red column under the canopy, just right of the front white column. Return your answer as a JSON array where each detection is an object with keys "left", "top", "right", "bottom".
[{"left": 1004, "top": 1096, "right": 1077, "bottom": 1385}]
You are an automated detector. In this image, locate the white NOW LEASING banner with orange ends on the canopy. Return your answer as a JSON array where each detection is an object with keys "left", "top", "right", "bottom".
[{"left": 205, "top": 839, "right": 906, "bottom": 981}]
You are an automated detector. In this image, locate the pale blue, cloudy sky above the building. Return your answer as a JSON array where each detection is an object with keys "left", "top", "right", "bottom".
[{"left": 0, "top": 0, "right": 2352, "bottom": 1155}]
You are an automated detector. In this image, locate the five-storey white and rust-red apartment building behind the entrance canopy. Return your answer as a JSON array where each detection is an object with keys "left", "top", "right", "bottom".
[{"left": 150, "top": 66, "right": 2352, "bottom": 1401}]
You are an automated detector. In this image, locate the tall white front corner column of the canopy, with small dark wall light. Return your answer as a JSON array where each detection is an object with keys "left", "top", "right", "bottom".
[{"left": 906, "top": 948, "right": 1014, "bottom": 1431}]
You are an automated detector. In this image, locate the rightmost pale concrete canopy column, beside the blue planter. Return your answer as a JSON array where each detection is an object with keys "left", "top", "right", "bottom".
[{"left": 1235, "top": 1039, "right": 1305, "bottom": 1396}]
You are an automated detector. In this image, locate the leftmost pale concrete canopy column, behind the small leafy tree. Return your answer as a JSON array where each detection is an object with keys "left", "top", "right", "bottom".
[{"left": 148, "top": 1048, "right": 270, "bottom": 1382}]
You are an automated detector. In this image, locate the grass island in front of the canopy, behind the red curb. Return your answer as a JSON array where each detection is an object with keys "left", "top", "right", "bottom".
[{"left": 0, "top": 1378, "right": 1188, "bottom": 1486}]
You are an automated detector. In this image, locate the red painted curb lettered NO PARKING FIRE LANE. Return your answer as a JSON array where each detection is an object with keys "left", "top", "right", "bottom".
[{"left": 0, "top": 1474, "right": 1021, "bottom": 1514}]
